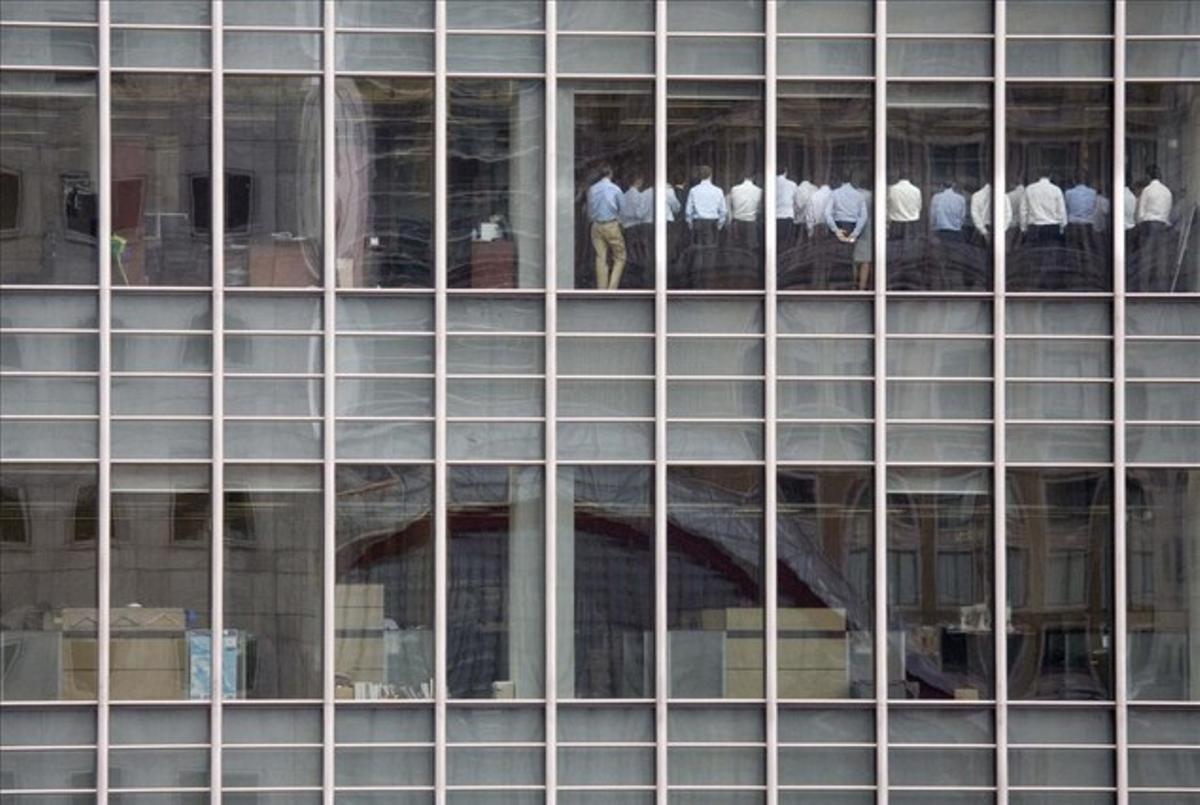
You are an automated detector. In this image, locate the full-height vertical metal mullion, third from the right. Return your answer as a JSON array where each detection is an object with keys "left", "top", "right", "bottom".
[{"left": 871, "top": 0, "right": 888, "bottom": 805}]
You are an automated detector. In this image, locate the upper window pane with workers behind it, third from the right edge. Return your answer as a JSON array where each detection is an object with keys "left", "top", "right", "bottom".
[{"left": 887, "top": 83, "right": 993, "bottom": 290}]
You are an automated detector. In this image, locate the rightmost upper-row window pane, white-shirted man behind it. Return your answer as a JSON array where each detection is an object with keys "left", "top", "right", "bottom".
[{"left": 1122, "top": 84, "right": 1200, "bottom": 293}]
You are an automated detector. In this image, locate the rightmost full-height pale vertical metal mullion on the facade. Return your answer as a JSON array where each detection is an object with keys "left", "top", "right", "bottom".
[{"left": 1109, "top": 0, "right": 1129, "bottom": 805}]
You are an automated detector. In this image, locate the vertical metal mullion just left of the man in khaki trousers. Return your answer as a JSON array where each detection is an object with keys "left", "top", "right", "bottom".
[{"left": 542, "top": 0, "right": 558, "bottom": 805}]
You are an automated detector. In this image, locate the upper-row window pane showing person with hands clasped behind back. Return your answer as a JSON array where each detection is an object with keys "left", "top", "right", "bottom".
[{"left": 775, "top": 82, "right": 875, "bottom": 290}]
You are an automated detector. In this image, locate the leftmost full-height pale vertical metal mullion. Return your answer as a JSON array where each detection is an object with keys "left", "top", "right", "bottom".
[{"left": 96, "top": 0, "right": 113, "bottom": 803}]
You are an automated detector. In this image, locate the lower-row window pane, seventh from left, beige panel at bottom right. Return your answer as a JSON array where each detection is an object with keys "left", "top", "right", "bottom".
[{"left": 666, "top": 467, "right": 763, "bottom": 698}]
